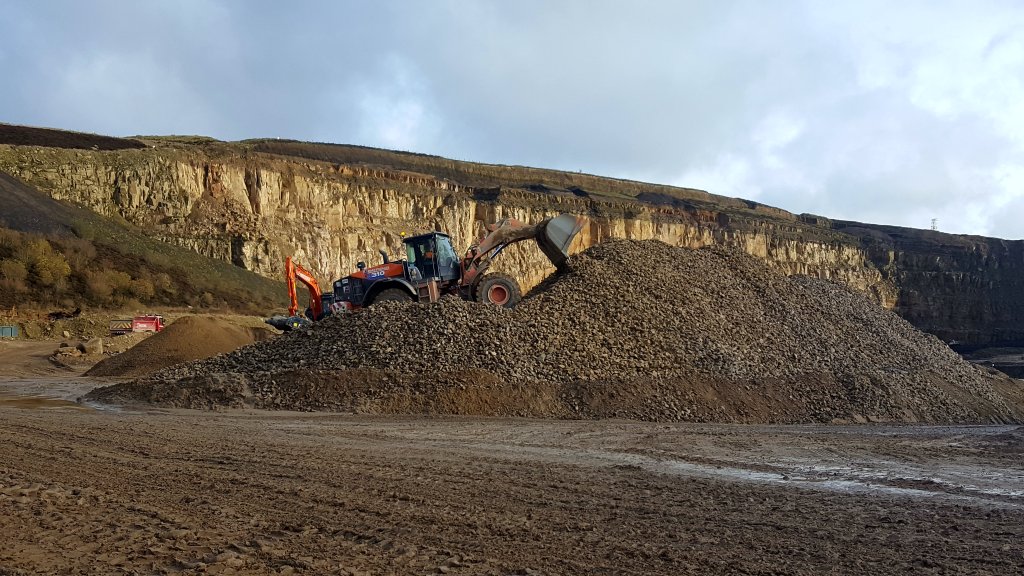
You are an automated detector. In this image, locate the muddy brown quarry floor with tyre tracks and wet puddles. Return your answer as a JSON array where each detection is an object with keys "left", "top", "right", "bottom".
[{"left": 0, "top": 343, "right": 1024, "bottom": 576}]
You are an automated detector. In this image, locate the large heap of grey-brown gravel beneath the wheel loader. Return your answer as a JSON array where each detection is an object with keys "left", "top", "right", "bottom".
[{"left": 91, "top": 241, "right": 1022, "bottom": 422}]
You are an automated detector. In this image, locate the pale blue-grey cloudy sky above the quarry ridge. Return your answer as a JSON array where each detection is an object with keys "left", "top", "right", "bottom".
[{"left": 6, "top": 0, "right": 1024, "bottom": 239}]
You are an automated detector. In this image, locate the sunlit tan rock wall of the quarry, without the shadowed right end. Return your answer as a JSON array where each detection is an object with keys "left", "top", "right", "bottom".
[{"left": 0, "top": 147, "right": 893, "bottom": 297}]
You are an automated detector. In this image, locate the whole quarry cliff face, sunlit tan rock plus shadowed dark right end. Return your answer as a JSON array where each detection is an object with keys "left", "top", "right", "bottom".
[{"left": 0, "top": 140, "right": 1024, "bottom": 340}]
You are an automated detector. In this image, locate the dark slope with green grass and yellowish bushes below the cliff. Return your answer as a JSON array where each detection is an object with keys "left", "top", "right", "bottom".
[{"left": 0, "top": 168, "right": 287, "bottom": 313}]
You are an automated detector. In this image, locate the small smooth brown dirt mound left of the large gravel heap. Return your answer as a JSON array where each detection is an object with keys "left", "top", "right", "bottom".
[{"left": 85, "top": 316, "right": 270, "bottom": 378}]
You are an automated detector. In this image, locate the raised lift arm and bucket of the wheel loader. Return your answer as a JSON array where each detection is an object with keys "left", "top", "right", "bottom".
[{"left": 461, "top": 214, "right": 584, "bottom": 288}]
